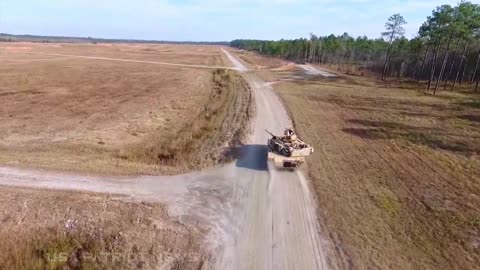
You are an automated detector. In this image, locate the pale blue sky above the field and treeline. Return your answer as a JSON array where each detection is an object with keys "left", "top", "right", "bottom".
[{"left": 0, "top": 0, "right": 480, "bottom": 41}]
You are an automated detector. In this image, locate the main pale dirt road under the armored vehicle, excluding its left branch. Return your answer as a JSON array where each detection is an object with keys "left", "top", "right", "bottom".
[{"left": 217, "top": 51, "right": 334, "bottom": 269}]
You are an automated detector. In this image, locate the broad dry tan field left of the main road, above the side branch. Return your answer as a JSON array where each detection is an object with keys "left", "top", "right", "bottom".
[{"left": 0, "top": 43, "right": 249, "bottom": 174}]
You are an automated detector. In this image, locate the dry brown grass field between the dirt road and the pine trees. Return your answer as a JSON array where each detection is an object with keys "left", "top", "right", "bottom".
[{"left": 237, "top": 51, "right": 480, "bottom": 269}]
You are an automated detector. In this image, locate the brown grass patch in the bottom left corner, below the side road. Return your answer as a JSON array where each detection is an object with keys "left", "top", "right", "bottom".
[{"left": 0, "top": 188, "right": 208, "bottom": 270}]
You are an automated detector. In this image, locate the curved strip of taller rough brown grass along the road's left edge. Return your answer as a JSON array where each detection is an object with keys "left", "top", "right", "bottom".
[{"left": 119, "top": 69, "right": 250, "bottom": 172}]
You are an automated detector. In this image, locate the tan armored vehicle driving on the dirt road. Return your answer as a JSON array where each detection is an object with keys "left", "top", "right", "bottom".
[{"left": 266, "top": 128, "right": 313, "bottom": 168}]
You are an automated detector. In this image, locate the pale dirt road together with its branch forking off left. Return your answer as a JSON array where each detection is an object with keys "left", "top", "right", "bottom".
[{"left": 0, "top": 47, "right": 335, "bottom": 270}]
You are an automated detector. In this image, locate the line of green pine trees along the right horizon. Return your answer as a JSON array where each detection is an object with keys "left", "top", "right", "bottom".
[{"left": 230, "top": 1, "right": 480, "bottom": 93}]
